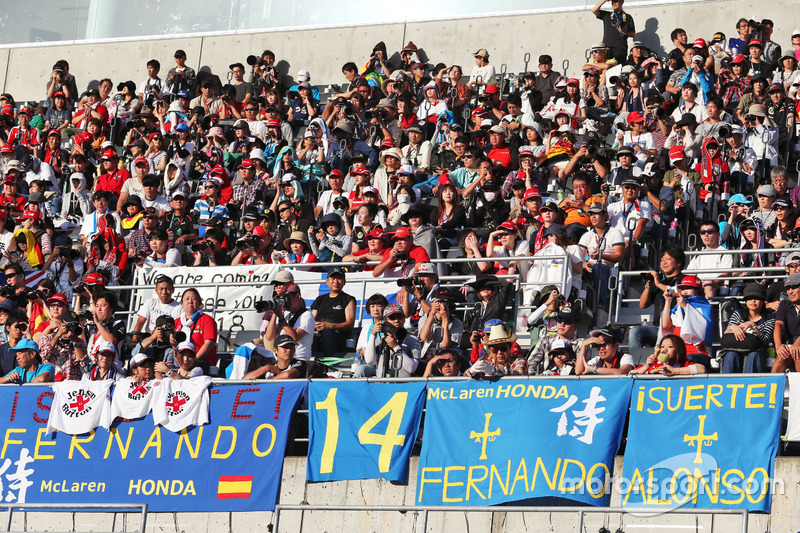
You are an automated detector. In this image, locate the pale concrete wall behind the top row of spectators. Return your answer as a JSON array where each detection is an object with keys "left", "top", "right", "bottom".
[{"left": 0, "top": 0, "right": 797, "bottom": 101}]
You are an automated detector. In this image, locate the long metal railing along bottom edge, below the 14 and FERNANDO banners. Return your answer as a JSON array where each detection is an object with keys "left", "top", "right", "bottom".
[{"left": 272, "top": 503, "right": 750, "bottom": 533}]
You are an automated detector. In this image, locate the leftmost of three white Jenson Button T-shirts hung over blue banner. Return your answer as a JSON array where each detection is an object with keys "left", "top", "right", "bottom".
[{"left": 47, "top": 379, "right": 114, "bottom": 435}]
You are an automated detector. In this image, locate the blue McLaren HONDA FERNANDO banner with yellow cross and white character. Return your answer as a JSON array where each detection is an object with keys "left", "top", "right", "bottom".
[{"left": 417, "top": 379, "right": 632, "bottom": 505}]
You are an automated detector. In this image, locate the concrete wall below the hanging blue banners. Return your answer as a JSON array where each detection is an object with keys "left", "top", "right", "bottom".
[{"left": 12, "top": 457, "right": 800, "bottom": 533}]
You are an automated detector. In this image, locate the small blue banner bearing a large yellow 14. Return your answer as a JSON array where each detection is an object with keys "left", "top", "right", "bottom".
[{"left": 306, "top": 381, "right": 425, "bottom": 483}]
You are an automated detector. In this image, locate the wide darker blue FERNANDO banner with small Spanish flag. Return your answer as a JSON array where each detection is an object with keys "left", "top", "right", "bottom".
[{"left": 0, "top": 382, "right": 306, "bottom": 512}]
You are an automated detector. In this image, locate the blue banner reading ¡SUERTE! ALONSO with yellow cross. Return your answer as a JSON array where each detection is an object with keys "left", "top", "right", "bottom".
[{"left": 620, "top": 374, "right": 786, "bottom": 512}]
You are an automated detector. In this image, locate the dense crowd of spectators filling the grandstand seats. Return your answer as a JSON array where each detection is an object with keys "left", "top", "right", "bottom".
[{"left": 0, "top": 0, "right": 800, "bottom": 383}]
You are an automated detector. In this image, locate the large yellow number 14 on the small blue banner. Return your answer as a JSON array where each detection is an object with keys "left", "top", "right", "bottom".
[{"left": 316, "top": 388, "right": 408, "bottom": 474}]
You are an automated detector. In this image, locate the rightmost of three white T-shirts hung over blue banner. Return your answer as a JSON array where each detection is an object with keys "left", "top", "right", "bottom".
[{"left": 153, "top": 376, "right": 211, "bottom": 433}]
